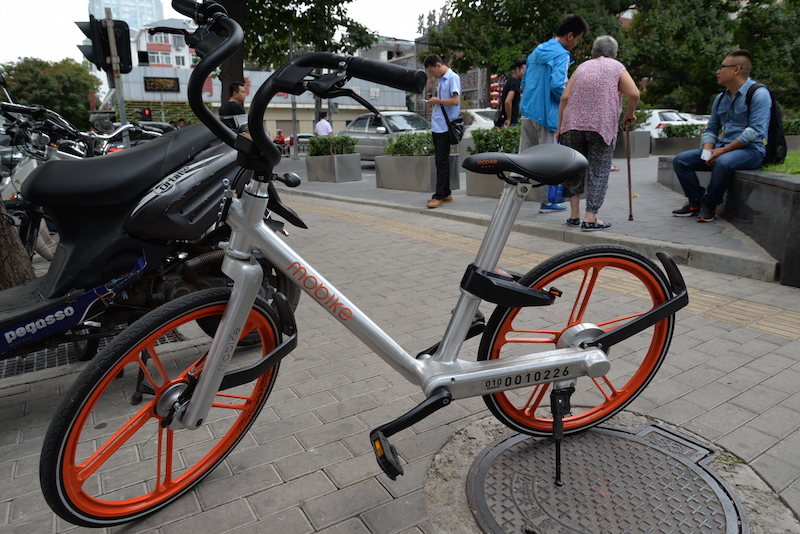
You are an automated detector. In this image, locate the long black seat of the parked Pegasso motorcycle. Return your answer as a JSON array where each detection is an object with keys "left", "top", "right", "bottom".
[{"left": 22, "top": 124, "right": 216, "bottom": 207}]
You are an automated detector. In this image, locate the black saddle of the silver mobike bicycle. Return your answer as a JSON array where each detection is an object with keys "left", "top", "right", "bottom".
[{"left": 462, "top": 144, "right": 589, "bottom": 185}]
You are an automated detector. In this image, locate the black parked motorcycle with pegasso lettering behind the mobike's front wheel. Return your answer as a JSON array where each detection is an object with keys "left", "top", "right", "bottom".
[{"left": 0, "top": 103, "right": 300, "bottom": 360}]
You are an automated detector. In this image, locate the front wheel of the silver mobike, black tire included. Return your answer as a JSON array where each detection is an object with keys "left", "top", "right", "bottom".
[{"left": 39, "top": 289, "right": 280, "bottom": 527}]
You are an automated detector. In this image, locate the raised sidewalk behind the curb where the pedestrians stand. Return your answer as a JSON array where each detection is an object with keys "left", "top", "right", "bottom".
[{"left": 276, "top": 156, "right": 777, "bottom": 281}]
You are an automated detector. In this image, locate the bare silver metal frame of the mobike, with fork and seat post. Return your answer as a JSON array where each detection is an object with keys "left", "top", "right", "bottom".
[{"left": 177, "top": 176, "right": 610, "bottom": 429}]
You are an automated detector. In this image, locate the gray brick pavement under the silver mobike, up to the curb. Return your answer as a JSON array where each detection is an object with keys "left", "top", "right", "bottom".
[{"left": 0, "top": 178, "right": 800, "bottom": 534}]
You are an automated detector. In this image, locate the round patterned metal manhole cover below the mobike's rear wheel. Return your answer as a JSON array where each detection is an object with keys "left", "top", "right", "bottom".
[{"left": 467, "top": 424, "right": 750, "bottom": 534}]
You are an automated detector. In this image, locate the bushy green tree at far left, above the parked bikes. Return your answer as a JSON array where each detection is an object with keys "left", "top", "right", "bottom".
[{"left": 2, "top": 58, "right": 100, "bottom": 129}]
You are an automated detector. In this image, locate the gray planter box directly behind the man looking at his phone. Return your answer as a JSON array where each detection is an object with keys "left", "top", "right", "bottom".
[{"left": 375, "top": 154, "right": 460, "bottom": 193}]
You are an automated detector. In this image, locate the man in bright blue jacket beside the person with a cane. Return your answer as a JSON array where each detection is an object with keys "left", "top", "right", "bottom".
[{"left": 519, "top": 14, "right": 589, "bottom": 213}]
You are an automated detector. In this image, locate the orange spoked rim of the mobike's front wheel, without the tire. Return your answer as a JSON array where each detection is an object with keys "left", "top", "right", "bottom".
[{"left": 61, "top": 305, "right": 276, "bottom": 518}]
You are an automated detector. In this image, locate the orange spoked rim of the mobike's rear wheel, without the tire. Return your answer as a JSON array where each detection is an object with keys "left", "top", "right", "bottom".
[{"left": 489, "top": 256, "right": 671, "bottom": 433}]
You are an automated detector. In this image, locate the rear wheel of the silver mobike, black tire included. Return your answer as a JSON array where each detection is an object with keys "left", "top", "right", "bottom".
[{"left": 478, "top": 245, "right": 675, "bottom": 437}]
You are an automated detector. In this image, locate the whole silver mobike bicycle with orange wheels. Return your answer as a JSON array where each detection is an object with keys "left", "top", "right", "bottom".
[{"left": 40, "top": 0, "right": 688, "bottom": 527}]
